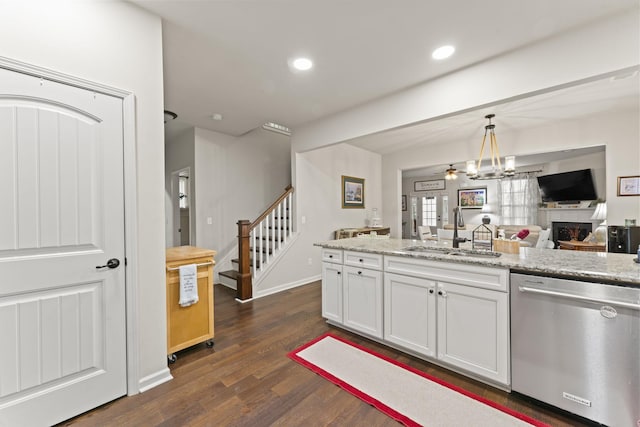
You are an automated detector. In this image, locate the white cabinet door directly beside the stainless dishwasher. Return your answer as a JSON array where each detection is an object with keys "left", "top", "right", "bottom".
[{"left": 437, "top": 282, "right": 510, "bottom": 385}]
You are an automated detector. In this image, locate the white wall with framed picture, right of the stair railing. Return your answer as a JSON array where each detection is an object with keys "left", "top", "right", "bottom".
[{"left": 254, "top": 144, "right": 386, "bottom": 296}]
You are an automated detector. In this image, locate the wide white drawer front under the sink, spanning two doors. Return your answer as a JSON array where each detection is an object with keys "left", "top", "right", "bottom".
[{"left": 384, "top": 256, "right": 509, "bottom": 292}]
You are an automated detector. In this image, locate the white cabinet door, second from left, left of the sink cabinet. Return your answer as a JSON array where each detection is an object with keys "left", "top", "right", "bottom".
[{"left": 343, "top": 265, "right": 382, "bottom": 338}]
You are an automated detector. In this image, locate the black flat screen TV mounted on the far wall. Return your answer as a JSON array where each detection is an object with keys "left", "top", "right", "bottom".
[{"left": 538, "top": 169, "right": 598, "bottom": 202}]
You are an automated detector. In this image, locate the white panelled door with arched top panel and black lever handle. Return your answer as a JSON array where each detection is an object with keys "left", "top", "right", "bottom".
[{"left": 0, "top": 69, "right": 126, "bottom": 426}]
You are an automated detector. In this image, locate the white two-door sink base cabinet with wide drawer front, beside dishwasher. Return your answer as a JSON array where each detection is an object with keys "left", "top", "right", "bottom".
[{"left": 384, "top": 256, "right": 510, "bottom": 385}]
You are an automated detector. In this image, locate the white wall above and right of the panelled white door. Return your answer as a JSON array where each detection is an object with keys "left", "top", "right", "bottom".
[{"left": 0, "top": 0, "right": 167, "bottom": 392}]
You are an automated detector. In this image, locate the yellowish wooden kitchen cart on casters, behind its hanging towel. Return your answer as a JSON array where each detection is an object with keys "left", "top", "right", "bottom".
[{"left": 166, "top": 246, "right": 216, "bottom": 363}]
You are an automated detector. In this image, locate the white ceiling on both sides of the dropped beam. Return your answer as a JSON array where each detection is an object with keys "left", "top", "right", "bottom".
[{"left": 129, "top": 0, "right": 639, "bottom": 147}]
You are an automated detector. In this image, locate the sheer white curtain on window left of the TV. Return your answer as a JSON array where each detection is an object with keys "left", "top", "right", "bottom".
[{"left": 498, "top": 174, "right": 541, "bottom": 225}]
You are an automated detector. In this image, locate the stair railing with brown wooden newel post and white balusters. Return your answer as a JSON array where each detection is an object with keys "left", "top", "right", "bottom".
[{"left": 236, "top": 185, "right": 293, "bottom": 301}]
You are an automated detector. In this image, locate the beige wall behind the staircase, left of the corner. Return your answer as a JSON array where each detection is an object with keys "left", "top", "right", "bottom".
[{"left": 194, "top": 128, "right": 291, "bottom": 271}]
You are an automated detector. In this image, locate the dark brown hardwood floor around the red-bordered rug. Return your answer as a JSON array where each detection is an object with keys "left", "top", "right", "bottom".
[{"left": 60, "top": 282, "right": 583, "bottom": 427}]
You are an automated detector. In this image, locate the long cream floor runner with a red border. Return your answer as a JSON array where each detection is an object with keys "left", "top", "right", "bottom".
[{"left": 288, "top": 333, "right": 547, "bottom": 427}]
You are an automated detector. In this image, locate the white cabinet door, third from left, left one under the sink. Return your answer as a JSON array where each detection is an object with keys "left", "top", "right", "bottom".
[{"left": 384, "top": 273, "right": 436, "bottom": 357}]
